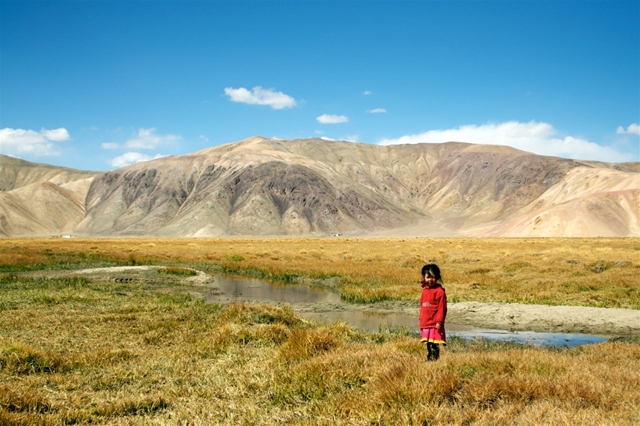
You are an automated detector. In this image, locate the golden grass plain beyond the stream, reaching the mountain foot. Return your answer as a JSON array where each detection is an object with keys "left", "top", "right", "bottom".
[{"left": 0, "top": 238, "right": 640, "bottom": 309}]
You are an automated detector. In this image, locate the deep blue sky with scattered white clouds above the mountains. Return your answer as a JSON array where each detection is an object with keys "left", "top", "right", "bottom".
[{"left": 0, "top": 0, "right": 640, "bottom": 170}]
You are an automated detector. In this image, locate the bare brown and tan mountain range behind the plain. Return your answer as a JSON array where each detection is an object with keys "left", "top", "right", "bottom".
[{"left": 0, "top": 137, "right": 640, "bottom": 236}]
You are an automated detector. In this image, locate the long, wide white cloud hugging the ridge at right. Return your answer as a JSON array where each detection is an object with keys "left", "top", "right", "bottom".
[{"left": 379, "top": 121, "right": 634, "bottom": 162}]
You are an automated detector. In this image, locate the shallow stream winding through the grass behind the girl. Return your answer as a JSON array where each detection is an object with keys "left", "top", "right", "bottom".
[{"left": 203, "top": 275, "right": 607, "bottom": 347}]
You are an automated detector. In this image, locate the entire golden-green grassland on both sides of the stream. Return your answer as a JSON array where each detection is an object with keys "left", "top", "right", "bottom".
[{"left": 0, "top": 239, "right": 640, "bottom": 425}]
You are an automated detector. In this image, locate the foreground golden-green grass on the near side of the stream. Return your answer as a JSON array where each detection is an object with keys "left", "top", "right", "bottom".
[{"left": 0, "top": 275, "right": 640, "bottom": 425}]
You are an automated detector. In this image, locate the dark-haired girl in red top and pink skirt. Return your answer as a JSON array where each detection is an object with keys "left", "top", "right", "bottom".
[{"left": 420, "top": 263, "right": 447, "bottom": 361}]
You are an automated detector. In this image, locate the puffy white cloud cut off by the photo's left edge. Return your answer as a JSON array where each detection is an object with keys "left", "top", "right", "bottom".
[{"left": 0, "top": 127, "right": 71, "bottom": 156}]
